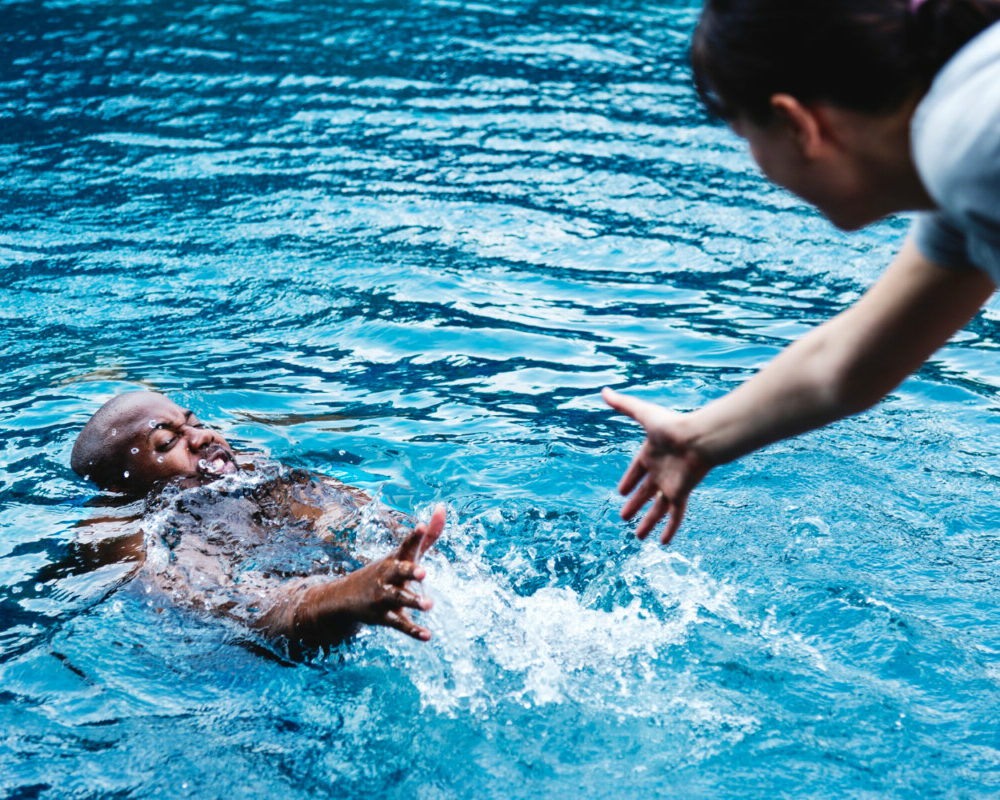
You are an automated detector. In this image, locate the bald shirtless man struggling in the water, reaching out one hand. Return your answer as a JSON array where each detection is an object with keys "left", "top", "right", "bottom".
[{"left": 71, "top": 391, "right": 445, "bottom": 652}]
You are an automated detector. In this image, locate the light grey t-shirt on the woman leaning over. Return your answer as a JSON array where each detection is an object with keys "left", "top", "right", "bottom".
[{"left": 910, "top": 23, "right": 1000, "bottom": 284}]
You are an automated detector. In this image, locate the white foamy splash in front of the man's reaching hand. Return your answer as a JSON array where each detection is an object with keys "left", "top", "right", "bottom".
[{"left": 369, "top": 510, "right": 758, "bottom": 741}]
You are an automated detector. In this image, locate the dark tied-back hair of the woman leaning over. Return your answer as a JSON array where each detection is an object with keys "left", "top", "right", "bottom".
[{"left": 691, "top": 0, "right": 1000, "bottom": 124}]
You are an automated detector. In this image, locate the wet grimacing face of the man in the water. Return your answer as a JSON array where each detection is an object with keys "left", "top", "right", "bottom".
[{"left": 112, "top": 392, "right": 237, "bottom": 491}]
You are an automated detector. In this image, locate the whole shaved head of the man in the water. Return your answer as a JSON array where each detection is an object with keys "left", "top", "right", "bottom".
[{"left": 70, "top": 392, "right": 237, "bottom": 494}]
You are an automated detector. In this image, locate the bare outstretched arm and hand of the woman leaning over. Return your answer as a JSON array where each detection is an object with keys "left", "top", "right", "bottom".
[{"left": 603, "top": 240, "right": 995, "bottom": 544}]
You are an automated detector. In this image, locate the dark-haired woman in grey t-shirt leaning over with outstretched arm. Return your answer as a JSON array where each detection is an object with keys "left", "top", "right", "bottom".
[{"left": 604, "top": 0, "right": 1000, "bottom": 543}]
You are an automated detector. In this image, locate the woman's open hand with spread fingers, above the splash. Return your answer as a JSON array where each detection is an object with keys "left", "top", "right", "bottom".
[{"left": 601, "top": 388, "right": 712, "bottom": 544}]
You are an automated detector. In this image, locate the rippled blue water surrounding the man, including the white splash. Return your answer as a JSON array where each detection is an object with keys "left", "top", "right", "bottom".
[{"left": 0, "top": 0, "right": 1000, "bottom": 799}]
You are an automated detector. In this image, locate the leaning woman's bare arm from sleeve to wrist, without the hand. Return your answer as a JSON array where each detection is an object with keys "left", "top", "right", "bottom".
[{"left": 678, "top": 243, "right": 994, "bottom": 464}]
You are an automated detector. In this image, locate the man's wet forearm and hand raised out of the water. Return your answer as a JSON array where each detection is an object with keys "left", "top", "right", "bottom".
[{"left": 293, "top": 505, "right": 445, "bottom": 643}]
